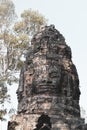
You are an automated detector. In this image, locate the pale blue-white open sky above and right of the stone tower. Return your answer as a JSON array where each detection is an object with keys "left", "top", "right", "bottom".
[{"left": 0, "top": 0, "right": 87, "bottom": 130}]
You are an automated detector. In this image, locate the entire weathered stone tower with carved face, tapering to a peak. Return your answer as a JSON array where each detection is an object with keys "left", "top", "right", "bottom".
[{"left": 8, "top": 25, "right": 87, "bottom": 130}]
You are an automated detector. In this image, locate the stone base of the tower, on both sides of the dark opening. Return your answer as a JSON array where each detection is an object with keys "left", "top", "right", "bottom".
[{"left": 8, "top": 114, "right": 87, "bottom": 130}]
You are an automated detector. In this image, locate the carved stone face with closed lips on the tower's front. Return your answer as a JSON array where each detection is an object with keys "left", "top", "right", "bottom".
[{"left": 31, "top": 57, "right": 61, "bottom": 95}]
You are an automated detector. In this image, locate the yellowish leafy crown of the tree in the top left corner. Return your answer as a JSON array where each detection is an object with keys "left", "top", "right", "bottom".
[{"left": 0, "top": 0, "right": 16, "bottom": 28}]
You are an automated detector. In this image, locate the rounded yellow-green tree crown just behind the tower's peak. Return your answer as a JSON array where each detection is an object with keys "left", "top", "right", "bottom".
[{"left": 14, "top": 9, "right": 46, "bottom": 37}]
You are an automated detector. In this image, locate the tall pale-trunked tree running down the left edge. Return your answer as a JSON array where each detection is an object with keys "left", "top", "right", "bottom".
[{"left": 0, "top": 0, "right": 16, "bottom": 120}]
